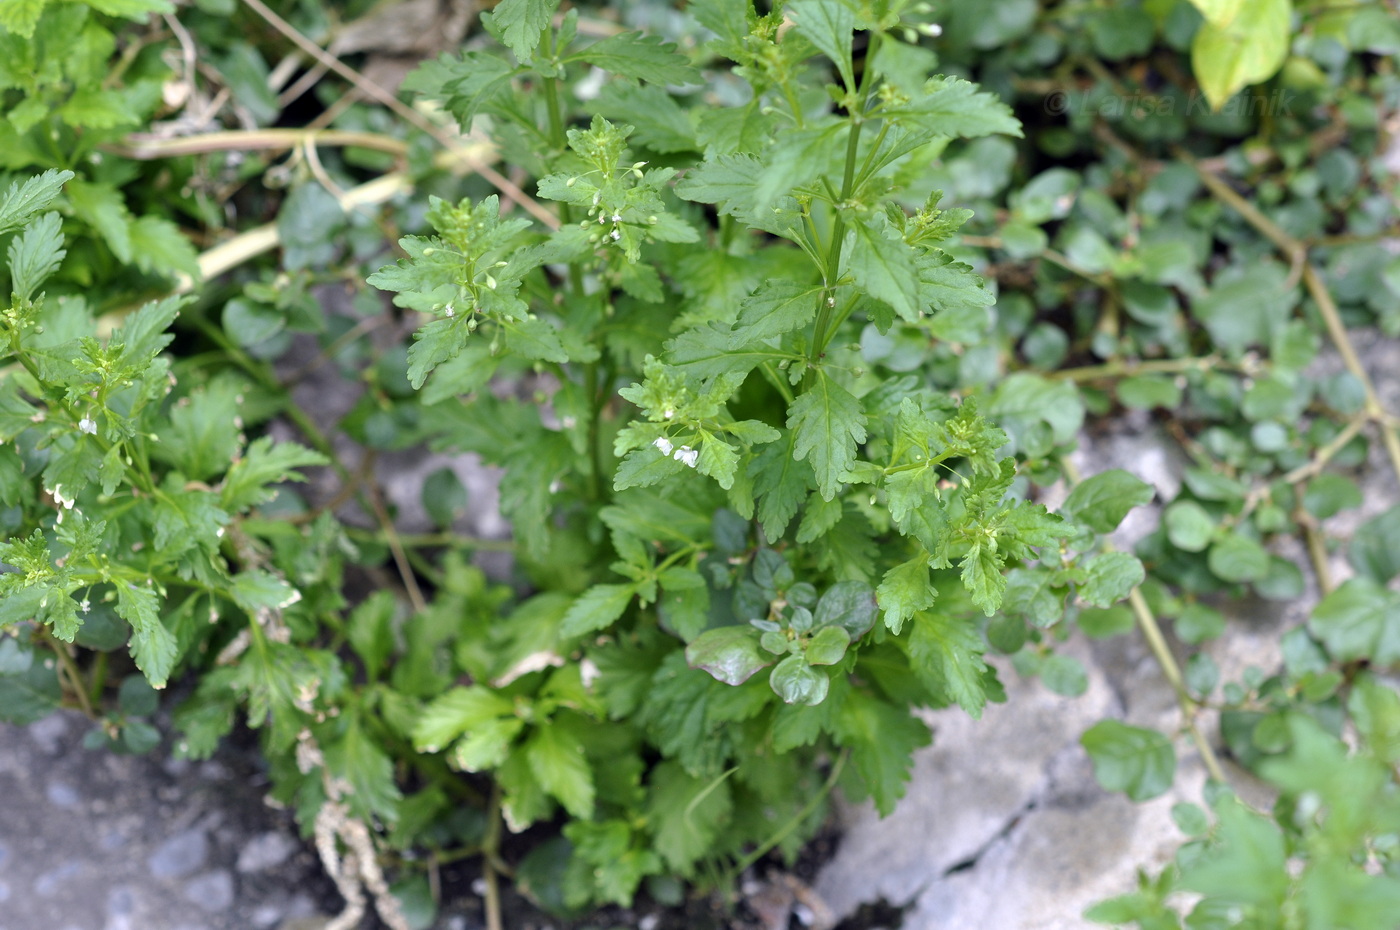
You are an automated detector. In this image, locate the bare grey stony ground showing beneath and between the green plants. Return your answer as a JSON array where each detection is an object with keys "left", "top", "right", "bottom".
[{"left": 0, "top": 339, "right": 1400, "bottom": 930}]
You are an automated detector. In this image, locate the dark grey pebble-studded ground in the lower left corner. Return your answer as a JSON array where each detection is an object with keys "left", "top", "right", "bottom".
[{"left": 0, "top": 712, "right": 339, "bottom": 930}]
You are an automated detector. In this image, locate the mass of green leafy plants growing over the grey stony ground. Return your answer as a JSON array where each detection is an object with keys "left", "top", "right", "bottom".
[{"left": 0, "top": 0, "right": 1400, "bottom": 926}]
